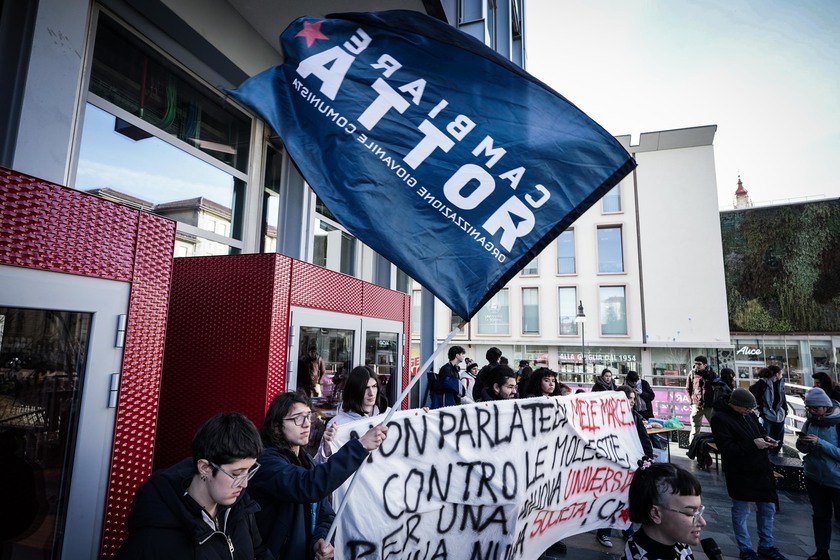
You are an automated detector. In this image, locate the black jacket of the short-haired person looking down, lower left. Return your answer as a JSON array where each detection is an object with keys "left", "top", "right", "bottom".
[{"left": 115, "top": 459, "right": 270, "bottom": 560}]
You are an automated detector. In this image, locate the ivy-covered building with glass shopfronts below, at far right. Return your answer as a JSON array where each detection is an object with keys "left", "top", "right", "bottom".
[{"left": 720, "top": 195, "right": 840, "bottom": 390}]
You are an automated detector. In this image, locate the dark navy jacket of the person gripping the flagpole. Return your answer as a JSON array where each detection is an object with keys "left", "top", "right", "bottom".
[{"left": 248, "top": 439, "right": 368, "bottom": 560}]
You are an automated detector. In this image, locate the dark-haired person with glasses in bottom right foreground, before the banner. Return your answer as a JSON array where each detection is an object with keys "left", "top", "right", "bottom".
[{"left": 621, "top": 460, "right": 706, "bottom": 560}]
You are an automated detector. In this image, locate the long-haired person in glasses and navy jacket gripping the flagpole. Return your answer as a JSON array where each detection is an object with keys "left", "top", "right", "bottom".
[{"left": 248, "top": 392, "right": 388, "bottom": 560}]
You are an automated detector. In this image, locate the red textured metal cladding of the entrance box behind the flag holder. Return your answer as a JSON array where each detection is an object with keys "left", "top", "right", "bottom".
[{"left": 155, "top": 254, "right": 410, "bottom": 468}]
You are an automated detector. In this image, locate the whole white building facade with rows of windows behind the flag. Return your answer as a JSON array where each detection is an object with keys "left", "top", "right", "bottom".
[{"left": 411, "top": 126, "right": 732, "bottom": 400}]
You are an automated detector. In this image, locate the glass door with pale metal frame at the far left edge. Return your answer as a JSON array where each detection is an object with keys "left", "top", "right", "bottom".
[{"left": 0, "top": 266, "right": 130, "bottom": 558}]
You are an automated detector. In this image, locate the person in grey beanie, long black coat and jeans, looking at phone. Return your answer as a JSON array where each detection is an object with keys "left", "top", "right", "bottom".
[{"left": 712, "top": 387, "right": 787, "bottom": 560}]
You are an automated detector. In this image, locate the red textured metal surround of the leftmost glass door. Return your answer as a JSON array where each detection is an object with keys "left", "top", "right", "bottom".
[{"left": 0, "top": 168, "right": 175, "bottom": 557}]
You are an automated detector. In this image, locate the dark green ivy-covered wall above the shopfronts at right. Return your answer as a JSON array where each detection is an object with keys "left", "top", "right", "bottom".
[{"left": 720, "top": 199, "right": 840, "bottom": 333}]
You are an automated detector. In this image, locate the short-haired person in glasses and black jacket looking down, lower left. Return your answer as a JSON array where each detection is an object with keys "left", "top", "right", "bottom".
[{"left": 116, "top": 412, "right": 271, "bottom": 560}]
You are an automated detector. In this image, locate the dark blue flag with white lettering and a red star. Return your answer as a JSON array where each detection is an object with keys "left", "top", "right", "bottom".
[{"left": 230, "top": 10, "right": 636, "bottom": 319}]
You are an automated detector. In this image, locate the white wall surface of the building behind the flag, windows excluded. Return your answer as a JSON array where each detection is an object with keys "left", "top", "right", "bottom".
[{"left": 415, "top": 126, "right": 730, "bottom": 376}]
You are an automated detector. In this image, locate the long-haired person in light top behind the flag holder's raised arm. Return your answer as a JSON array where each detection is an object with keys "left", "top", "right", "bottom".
[{"left": 312, "top": 366, "right": 381, "bottom": 464}]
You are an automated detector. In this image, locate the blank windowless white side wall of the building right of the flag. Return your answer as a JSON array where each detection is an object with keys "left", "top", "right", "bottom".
[{"left": 636, "top": 131, "right": 729, "bottom": 348}]
